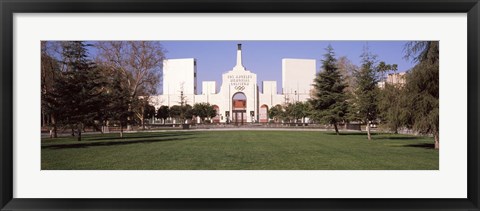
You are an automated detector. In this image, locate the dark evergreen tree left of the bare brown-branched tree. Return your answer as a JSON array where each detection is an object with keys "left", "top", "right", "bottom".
[{"left": 54, "top": 41, "right": 107, "bottom": 141}]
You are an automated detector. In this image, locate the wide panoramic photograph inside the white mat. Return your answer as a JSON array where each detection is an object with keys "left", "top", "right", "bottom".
[{"left": 40, "top": 40, "right": 443, "bottom": 171}]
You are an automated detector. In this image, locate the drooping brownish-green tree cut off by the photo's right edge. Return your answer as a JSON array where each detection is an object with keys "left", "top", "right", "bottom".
[{"left": 405, "top": 41, "right": 440, "bottom": 149}]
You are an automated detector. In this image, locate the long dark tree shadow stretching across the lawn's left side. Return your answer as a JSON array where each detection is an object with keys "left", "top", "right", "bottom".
[{"left": 42, "top": 134, "right": 195, "bottom": 149}]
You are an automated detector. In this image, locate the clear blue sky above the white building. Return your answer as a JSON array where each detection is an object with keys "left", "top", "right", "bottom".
[{"left": 159, "top": 41, "right": 414, "bottom": 92}]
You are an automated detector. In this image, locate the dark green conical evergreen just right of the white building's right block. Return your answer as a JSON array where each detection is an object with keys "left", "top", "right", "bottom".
[{"left": 310, "top": 45, "right": 347, "bottom": 135}]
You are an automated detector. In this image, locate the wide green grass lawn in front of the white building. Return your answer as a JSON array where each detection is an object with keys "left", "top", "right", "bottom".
[{"left": 41, "top": 131, "right": 439, "bottom": 170}]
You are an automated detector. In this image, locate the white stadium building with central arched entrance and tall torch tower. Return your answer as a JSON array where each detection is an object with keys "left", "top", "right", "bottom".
[{"left": 152, "top": 44, "right": 316, "bottom": 123}]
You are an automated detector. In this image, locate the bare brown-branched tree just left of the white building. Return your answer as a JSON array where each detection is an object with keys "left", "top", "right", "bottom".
[{"left": 95, "top": 41, "right": 165, "bottom": 129}]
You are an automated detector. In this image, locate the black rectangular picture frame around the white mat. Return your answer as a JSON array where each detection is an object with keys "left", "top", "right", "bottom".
[{"left": 0, "top": 0, "right": 480, "bottom": 210}]
